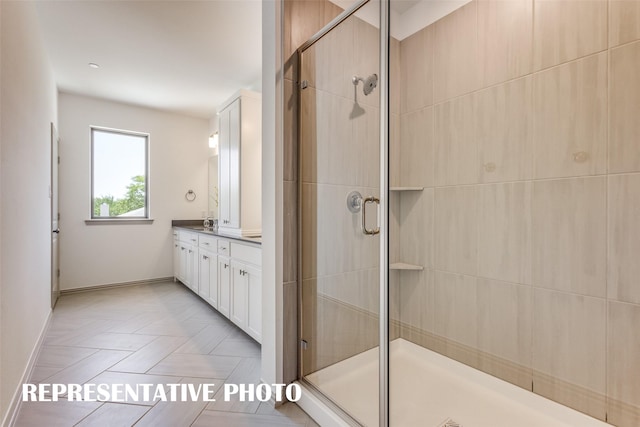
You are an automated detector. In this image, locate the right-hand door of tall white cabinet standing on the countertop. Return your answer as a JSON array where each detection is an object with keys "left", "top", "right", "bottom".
[{"left": 227, "top": 99, "right": 241, "bottom": 228}]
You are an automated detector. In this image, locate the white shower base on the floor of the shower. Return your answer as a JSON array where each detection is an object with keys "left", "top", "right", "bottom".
[{"left": 298, "top": 339, "right": 610, "bottom": 427}]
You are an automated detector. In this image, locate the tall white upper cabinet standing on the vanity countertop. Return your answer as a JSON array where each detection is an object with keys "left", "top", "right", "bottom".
[{"left": 218, "top": 90, "right": 262, "bottom": 237}]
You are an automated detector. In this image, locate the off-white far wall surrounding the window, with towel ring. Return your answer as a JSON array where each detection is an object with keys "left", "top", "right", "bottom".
[{"left": 58, "top": 93, "right": 209, "bottom": 290}]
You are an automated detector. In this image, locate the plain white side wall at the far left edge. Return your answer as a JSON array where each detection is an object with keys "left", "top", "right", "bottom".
[{"left": 0, "top": 1, "right": 57, "bottom": 424}]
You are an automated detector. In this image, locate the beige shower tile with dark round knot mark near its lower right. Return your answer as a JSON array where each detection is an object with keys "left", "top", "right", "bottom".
[{"left": 533, "top": 52, "right": 607, "bottom": 178}]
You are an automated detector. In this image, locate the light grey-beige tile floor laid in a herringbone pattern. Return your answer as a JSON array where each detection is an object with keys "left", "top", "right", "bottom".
[{"left": 15, "top": 282, "right": 317, "bottom": 427}]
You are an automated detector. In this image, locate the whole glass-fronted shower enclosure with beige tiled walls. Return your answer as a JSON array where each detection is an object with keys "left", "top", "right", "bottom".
[{"left": 298, "top": 0, "right": 640, "bottom": 427}]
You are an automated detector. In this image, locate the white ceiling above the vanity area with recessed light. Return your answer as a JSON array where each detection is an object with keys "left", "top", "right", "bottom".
[{"left": 36, "top": 0, "right": 262, "bottom": 118}]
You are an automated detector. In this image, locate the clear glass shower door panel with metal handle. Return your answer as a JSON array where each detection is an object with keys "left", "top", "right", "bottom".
[{"left": 299, "top": 2, "right": 381, "bottom": 426}]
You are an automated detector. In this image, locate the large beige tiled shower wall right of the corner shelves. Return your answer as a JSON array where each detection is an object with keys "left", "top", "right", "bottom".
[{"left": 391, "top": 0, "right": 640, "bottom": 427}]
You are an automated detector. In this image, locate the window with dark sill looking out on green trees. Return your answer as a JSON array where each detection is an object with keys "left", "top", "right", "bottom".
[{"left": 91, "top": 127, "right": 149, "bottom": 220}]
